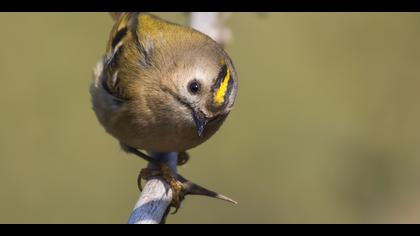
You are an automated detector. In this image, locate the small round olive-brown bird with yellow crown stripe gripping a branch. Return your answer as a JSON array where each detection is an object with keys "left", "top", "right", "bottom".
[{"left": 90, "top": 12, "right": 238, "bottom": 209}]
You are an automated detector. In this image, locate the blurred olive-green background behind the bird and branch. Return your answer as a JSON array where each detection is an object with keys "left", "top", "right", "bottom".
[{"left": 0, "top": 13, "right": 420, "bottom": 223}]
